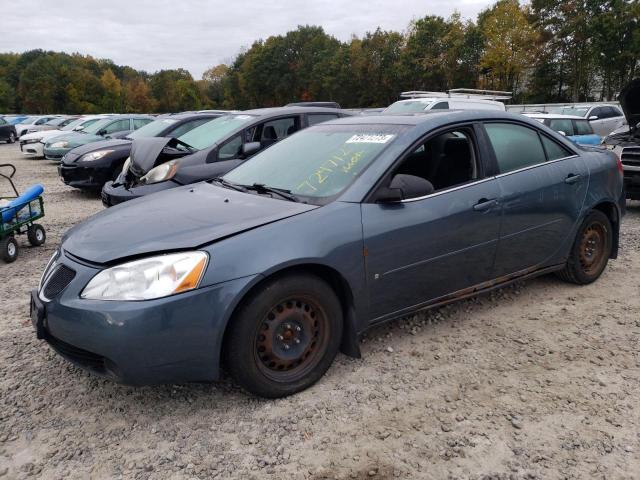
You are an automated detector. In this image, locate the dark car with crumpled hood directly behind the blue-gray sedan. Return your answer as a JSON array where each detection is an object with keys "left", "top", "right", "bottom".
[{"left": 102, "top": 107, "right": 352, "bottom": 207}]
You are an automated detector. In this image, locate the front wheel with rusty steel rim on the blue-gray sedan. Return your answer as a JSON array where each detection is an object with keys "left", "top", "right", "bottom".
[{"left": 223, "top": 274, "right": 343, "bottom": 398}]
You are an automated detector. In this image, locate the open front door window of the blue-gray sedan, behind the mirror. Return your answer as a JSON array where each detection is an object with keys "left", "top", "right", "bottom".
[{"left": 395, "top": 128, "right": 478, "bottom": 197}]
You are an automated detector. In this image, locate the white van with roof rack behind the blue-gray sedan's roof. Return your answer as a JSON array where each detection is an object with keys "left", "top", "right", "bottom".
[{"left": 382, "top": 89, "right": 511, "bottom": 113}]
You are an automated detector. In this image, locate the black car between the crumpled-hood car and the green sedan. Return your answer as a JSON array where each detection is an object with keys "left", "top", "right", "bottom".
[{"left": 58, "top": 113, "right": 220, "bottom": 190}]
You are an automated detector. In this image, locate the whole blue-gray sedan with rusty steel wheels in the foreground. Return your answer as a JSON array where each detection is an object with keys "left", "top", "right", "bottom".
[{"left": 31, "top": 111, "right": 624, "bottom": 397}]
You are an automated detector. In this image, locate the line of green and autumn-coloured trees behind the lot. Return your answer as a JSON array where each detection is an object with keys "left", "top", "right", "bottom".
[{"left": 0, "top": 0, "right": 640, "bottom": 113}]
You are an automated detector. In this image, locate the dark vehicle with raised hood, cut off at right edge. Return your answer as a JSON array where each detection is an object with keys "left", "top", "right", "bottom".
[{"left": 602, "top": 78, "right": 640, "bottom": 200}]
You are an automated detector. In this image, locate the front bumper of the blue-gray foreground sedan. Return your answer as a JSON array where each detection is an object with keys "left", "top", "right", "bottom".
[{"left": 31, "top": 255, "right": 255, "bottom": 385}]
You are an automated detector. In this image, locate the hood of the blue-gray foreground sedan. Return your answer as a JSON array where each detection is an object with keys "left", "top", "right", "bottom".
[{"left": 62, "top": 182, "right": 319, "bottom": 264}]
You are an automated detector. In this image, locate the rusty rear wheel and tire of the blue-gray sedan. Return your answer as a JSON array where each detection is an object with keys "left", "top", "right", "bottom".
[{"left": 557, "top": 210, "right": 613, "bottom": 285}]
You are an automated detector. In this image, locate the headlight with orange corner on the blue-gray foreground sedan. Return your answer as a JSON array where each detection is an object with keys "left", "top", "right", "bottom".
[{"left": 80, "top": 251, "right": 209, "bottom": 300}]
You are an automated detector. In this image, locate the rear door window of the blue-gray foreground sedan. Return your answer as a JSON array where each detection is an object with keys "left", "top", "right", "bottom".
[{"left": 485, "top": 123, "right": 547, "bottom": 173}]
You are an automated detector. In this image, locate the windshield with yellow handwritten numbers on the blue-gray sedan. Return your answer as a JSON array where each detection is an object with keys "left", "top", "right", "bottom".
[{"left": 224, "top": 125, "right": 406, "bottom": 202}]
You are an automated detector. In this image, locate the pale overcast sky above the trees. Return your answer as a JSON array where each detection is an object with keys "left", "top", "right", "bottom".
[{"left": 0, "top": 0, "right": 493, "bottom": 79}]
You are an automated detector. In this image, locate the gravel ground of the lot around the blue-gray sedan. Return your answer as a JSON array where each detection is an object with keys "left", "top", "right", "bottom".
[{"left": 0, "top": 145, "right": 640, "bottom": 479}]
